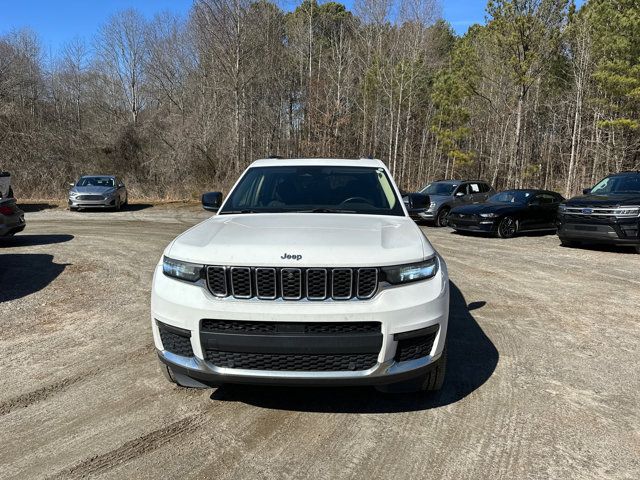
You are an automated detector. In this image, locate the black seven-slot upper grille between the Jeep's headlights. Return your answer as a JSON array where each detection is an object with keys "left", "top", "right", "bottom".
[{"left": 207, "top": 266, "right": 378, "bottom": 300}]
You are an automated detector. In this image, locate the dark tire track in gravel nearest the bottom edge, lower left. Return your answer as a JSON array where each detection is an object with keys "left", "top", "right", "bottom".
[{"left": 49, "top": 414, "right": 205, "bottom": 480}]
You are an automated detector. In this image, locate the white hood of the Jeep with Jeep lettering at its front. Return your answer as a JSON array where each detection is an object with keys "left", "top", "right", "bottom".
[{"left": 166, "top": 213, "right": 434, "bottom": 267}]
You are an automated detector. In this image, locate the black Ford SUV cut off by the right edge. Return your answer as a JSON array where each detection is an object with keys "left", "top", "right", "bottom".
[{"left": 558, "top": 172, "right": 640, "bottom": 253}]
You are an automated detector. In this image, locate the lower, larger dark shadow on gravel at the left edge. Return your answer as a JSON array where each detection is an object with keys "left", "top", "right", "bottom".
[{"left": 0, "top": 253, "right": 67, "bottom": 303}]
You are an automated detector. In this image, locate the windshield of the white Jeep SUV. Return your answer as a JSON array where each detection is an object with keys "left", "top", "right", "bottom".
[{"left": 220, "top": 166, "right": 404, "bottom": 215}]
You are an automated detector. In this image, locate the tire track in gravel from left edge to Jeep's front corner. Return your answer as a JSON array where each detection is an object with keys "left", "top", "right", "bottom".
[{"left": 0, "top": 344, "right": 154, "bottom": 417}]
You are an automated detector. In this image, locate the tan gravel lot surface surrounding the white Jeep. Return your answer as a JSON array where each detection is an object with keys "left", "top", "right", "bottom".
[{"left": 0, "top": 204, "right": 640, "bottom": 480}]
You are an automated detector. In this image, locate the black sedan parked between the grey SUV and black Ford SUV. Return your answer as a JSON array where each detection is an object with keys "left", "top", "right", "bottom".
[{"left": 449, "top": 189, "right": 564, "bottom": 238}]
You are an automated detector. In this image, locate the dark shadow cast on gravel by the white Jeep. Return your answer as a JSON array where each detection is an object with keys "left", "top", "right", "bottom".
[{"left": 211, "top": 282, "right": 499, "bottom": 413}]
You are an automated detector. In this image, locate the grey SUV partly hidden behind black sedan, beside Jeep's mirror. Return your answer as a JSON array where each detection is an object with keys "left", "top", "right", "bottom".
[{"left": 404, "top": 180, "right": 495, "bottom": 227}]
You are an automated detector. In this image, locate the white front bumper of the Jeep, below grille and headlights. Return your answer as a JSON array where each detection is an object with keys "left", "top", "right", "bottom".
[{"left": 151, "top": 261, "right": 449, "bottom": 385}]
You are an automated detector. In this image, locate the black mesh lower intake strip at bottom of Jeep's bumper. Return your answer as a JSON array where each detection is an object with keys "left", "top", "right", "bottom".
[{"left": 205, "top": 350, "right": 378, "bottom": 372}]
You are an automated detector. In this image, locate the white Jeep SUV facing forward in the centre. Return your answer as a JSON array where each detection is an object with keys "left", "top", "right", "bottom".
[{"left": 151, "top": 159, "right": 449, "bottom": 391}]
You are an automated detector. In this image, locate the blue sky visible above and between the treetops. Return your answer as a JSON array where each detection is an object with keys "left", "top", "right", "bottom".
[{"left": 0, "top": 0, "right": 581, "bottom": 53}]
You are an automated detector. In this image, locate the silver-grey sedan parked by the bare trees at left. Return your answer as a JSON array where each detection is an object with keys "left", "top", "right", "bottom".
[{"left": 69, "top": 175, "right": 129, "bottom": 210}]
